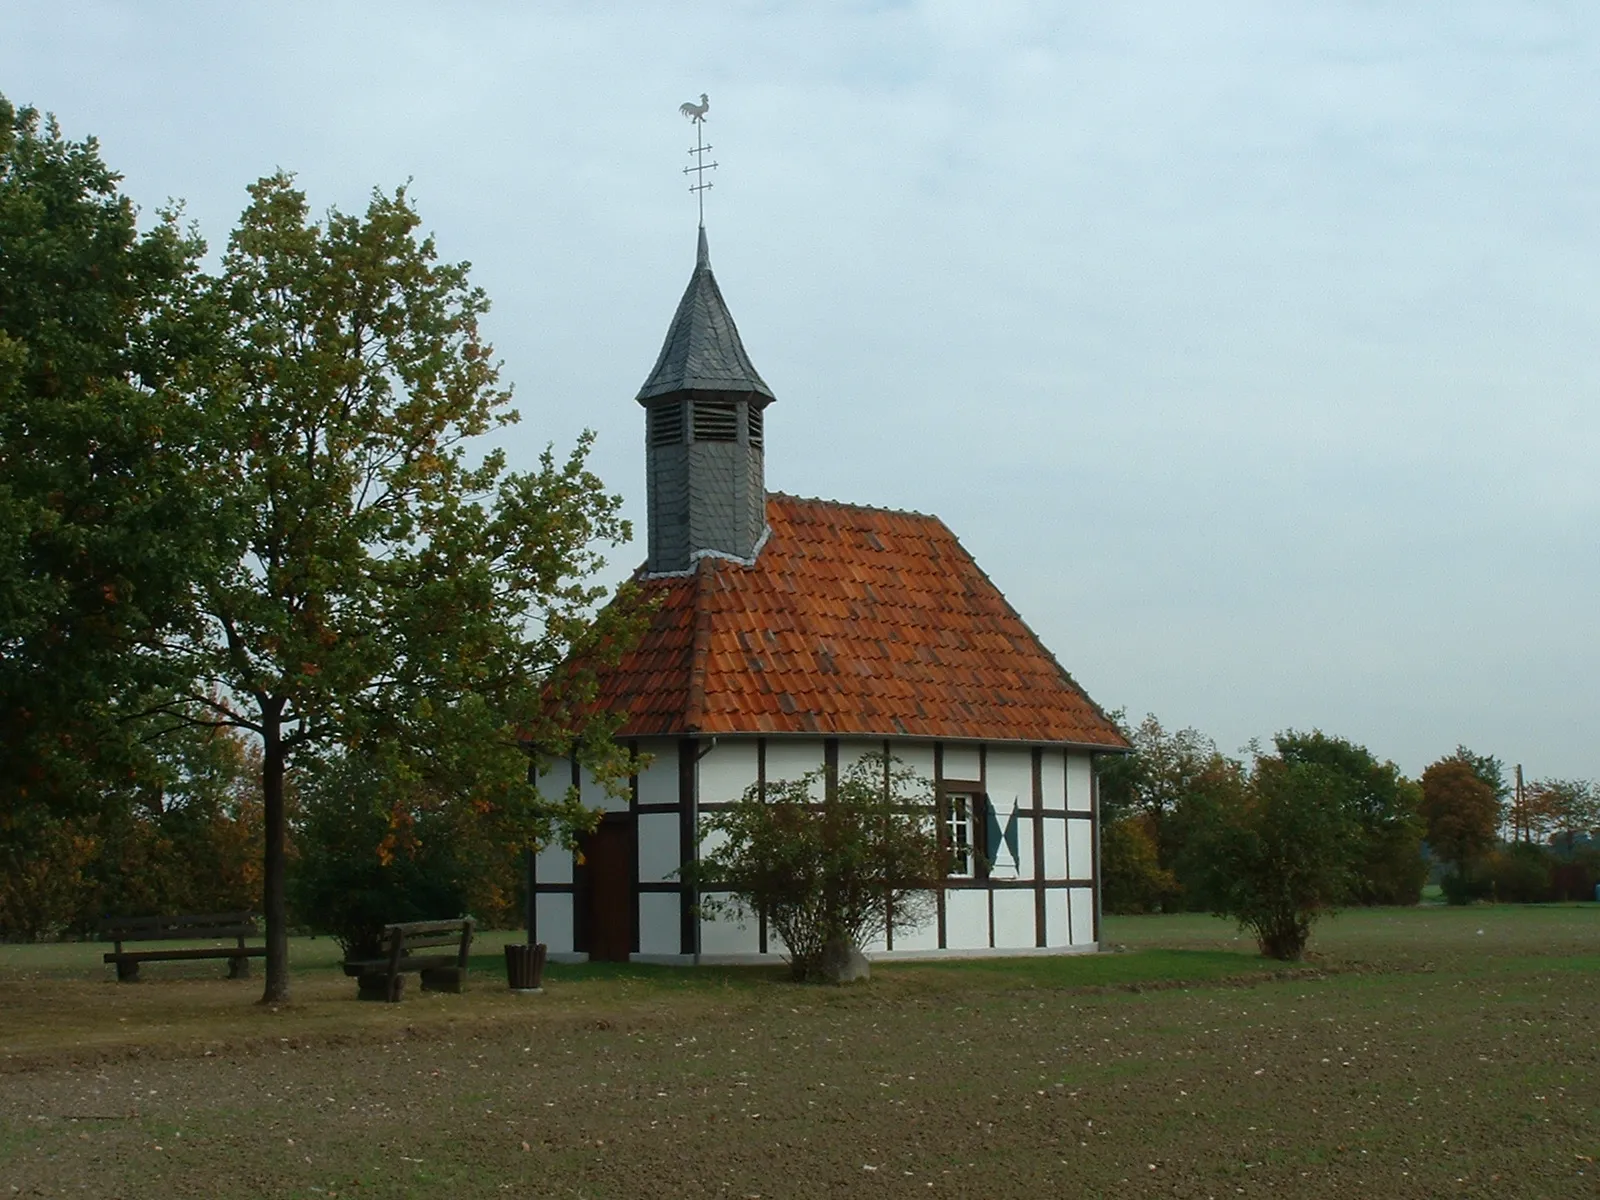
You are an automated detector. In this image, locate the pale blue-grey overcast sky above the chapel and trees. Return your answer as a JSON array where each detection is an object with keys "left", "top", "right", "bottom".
[{"left": 0, "top": 0, "right": 1600, "bottom": 778}]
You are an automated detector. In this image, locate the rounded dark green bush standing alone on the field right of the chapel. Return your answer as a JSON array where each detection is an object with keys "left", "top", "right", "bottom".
[{"left": 1192, "top": 757, "right": 1362, "bottom": 962}]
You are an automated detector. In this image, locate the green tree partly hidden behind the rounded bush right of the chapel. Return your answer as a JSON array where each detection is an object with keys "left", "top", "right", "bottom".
[{"left": 1272, "top": 730, "right": 1427, "bottom": 904}]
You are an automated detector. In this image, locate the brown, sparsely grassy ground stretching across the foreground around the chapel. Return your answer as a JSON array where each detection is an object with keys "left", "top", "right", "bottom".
[{"left": 0, "top": 906, "right": 1600, "bottom": 1197}]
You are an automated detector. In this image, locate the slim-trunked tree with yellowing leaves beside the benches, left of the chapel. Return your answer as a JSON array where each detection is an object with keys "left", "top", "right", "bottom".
[{"left": 164, "top": 173, "right": 632, "bottom": 1002}]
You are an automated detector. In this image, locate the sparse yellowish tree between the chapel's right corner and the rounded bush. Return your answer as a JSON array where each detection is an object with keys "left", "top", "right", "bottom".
[{"left": 1099, "top": 712, "right": 1238, "bottom": 907}]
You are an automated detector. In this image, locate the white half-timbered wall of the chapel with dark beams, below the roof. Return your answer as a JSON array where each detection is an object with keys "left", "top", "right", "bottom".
[{"left": 531, "top": 736, "right": 1099, "bottom": 962}]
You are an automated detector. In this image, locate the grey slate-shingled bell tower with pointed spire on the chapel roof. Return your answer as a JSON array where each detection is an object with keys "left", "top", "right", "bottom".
[{"left": 637, "top": 226, "right": 774, "bottom": 574}]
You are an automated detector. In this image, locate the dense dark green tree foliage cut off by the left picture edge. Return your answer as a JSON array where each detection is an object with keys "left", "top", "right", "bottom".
[{"left": 0, "top": 98, "right": 213, "bottom": 825}]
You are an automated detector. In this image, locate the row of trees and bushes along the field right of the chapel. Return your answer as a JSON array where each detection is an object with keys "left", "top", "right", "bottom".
[{"left": 1099, "top": 714, "right": 1600, "bottom": 957}]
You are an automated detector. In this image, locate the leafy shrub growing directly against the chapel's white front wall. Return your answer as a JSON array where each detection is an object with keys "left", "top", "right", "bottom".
[{"left": 683, "top": 755, "right": 950, "bottom": 981}]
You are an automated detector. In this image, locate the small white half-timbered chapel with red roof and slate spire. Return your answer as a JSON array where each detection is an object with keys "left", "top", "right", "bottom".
[{"left": 528, "top": 226, "right": 1126, "bottom": 963}]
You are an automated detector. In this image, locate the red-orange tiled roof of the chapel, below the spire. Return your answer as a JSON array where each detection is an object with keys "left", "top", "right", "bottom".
[{"left": 585, "top": 494, "right": 1126, "bottom": 749}]
